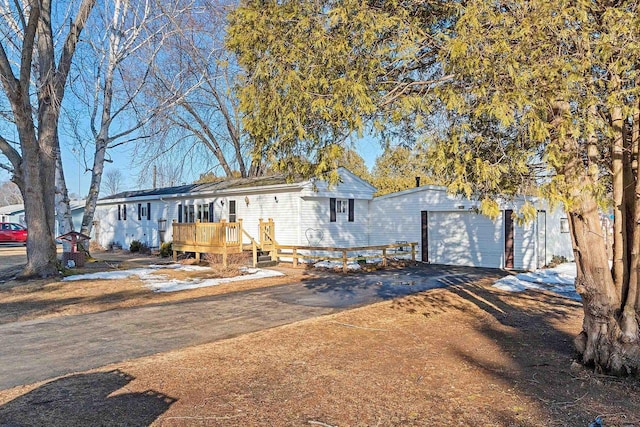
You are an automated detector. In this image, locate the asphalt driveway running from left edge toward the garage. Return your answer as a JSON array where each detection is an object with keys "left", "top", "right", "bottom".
[{"left": 0, "top": 265, "right": 499, "bottom": 389}]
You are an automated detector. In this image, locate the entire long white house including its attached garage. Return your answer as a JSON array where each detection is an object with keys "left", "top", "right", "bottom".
[{"left": 93, "top": 168, "right": 573, "bottom": 270}]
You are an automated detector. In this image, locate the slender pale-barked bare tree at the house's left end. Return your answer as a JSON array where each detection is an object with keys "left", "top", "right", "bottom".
[{"left": 60, "top": 0, "right": 186, "bottom": 241}]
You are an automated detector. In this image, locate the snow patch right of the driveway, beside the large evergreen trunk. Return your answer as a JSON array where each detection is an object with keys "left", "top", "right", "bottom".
[{"left": 493, "top": 263, "right": 580, "bottom": 301}]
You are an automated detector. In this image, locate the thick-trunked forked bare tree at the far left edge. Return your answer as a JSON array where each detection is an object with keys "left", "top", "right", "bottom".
[{"left": 0, "top": 0, "right": 95, "bottom": 278}]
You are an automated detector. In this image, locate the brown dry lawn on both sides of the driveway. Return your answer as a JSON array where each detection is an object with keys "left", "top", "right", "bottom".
[{"left": 0, "top": 254, "right": 640, "bottom": 427}]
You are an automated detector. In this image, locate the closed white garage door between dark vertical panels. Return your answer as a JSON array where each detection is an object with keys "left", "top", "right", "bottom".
[{"left": 423, "top": 212, "right": 505, "bottom": 268}]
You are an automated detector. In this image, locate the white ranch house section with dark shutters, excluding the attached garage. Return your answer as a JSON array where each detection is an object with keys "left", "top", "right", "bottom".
[{"left": 92, "top": 169, "right": 376, "bottom": 248}]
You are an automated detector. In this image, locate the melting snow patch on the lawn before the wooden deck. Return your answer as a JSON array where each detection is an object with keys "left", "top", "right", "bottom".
[{"left": 62, "top": 264, "right": 283, "bottom": 292}]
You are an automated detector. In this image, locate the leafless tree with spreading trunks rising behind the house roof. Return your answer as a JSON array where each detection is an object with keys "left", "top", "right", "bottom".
[{"left": 141, "top": 1, "right": 260, "bottom": 177}]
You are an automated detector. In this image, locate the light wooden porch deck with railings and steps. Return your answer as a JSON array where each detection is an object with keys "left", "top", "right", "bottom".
[{"left": 172, "top": 218, "right": 276, "bottom": 267}]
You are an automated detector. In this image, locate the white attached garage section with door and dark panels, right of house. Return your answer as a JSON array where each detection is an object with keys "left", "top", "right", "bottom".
[{"left": 369, "top": 185, "right": 573, "bottom": 270}]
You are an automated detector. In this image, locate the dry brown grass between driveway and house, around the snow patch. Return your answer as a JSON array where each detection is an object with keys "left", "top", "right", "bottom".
[{"left": 0, "top": 251, "right": 306, "bottom": 324}]
